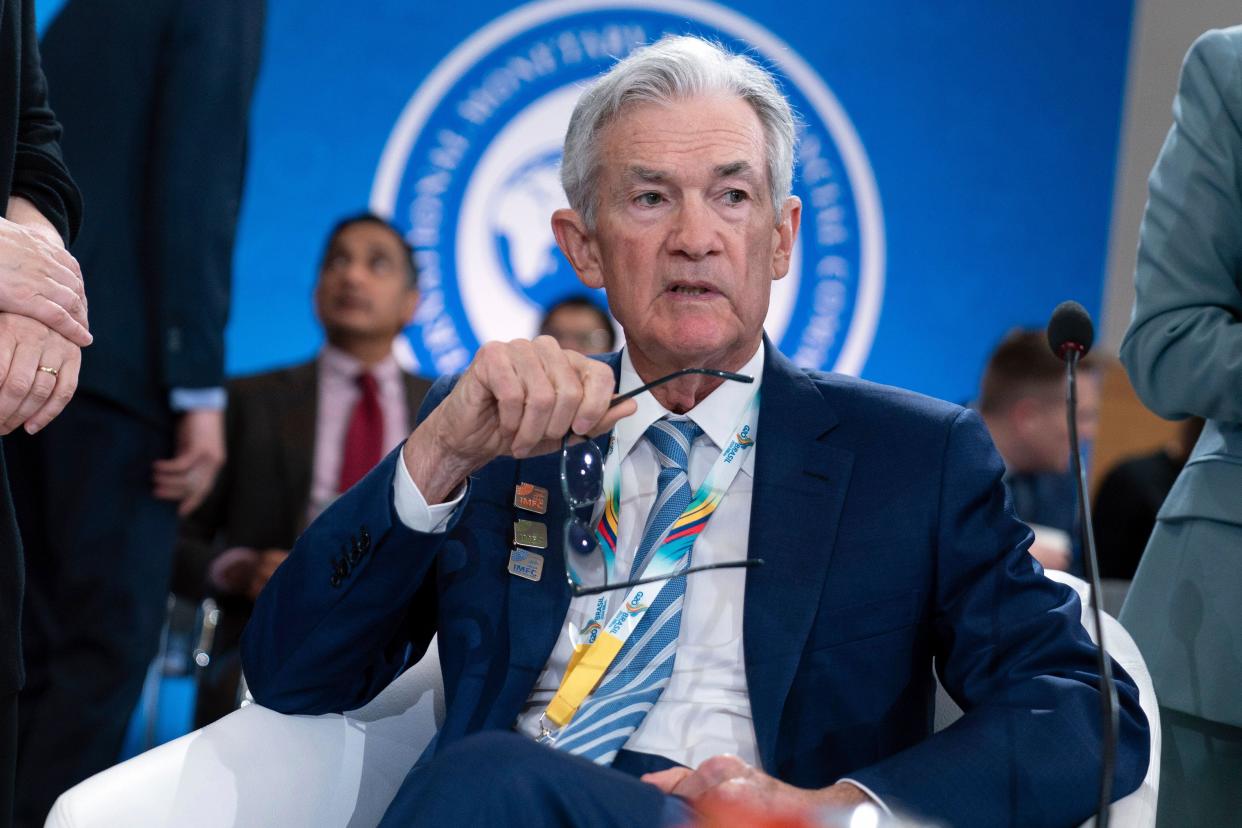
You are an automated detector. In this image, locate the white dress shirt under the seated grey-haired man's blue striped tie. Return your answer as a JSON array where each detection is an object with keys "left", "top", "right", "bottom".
[{"left": 518, "top": 344, "right": 764, "bottom": 767}]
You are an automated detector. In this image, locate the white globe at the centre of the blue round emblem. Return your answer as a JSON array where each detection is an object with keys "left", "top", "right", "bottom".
[{"left": 488, "top": 150, "right": 602, "bottom": 308}]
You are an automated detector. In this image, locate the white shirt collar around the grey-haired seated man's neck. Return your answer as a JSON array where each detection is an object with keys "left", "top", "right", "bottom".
[{"left": 614, "top": 341, "right": 765, "bottom": 469}]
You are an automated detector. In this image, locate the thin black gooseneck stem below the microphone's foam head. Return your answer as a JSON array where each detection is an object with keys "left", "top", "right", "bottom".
[{"left": 1063, "top": 344, "right": 1119, "bottom": 828}]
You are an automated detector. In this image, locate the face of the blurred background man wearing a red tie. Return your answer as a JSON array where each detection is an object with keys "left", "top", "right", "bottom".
[{"left": 314, "top": 222, "right": 419, "bottom": 340}]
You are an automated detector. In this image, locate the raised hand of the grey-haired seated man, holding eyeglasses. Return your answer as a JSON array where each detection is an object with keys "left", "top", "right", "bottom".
[{"left": 402, "top": 336, "right": 637, "bottom": 504}]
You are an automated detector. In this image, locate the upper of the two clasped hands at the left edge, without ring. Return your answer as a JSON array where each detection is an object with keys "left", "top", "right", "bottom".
[{"left": 0, "top": 218, "right": 92, "bottom": 348}]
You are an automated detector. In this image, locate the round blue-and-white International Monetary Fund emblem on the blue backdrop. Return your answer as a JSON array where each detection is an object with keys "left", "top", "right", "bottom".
[{"left": 371, "top": 0, "right": 884, "bottom": 374}]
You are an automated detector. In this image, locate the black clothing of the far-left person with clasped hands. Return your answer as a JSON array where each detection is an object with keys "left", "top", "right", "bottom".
[{"left": 0, "top": 0, "right": 82, "bottom": 826}]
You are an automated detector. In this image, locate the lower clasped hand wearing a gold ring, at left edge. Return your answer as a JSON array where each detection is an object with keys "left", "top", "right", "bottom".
[{"left": 0, "top": 313, "right": 82, "bottom": 434}]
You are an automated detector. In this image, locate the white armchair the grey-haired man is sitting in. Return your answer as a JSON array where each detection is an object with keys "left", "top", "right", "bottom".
[{"left": 47, "top": 572, "right": 1160, "bottom": 828}]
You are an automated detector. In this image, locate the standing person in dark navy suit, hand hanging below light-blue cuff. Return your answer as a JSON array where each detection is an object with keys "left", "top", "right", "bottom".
[{"left": 5, "top": 0, "right": 265, "bottom": 826}]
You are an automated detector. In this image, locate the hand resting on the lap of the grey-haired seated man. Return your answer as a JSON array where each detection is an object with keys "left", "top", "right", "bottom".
[{"left": 642, "top": 754, "right": 871, "bottom": 816}]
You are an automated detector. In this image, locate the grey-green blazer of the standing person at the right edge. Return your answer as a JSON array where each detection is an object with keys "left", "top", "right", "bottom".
[{"left": 1120, "top": 26, "right": 1242, "bottom": 726}]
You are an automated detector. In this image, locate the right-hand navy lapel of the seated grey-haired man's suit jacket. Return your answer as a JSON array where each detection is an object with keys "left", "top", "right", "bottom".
[{"left": 743, "top": 343, "right": 853, "bottom": 771}]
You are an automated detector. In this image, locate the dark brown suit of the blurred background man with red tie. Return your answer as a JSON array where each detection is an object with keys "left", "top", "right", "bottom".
[{"left": 174, "top": 360, "right": 431, "bottom": 727}]
